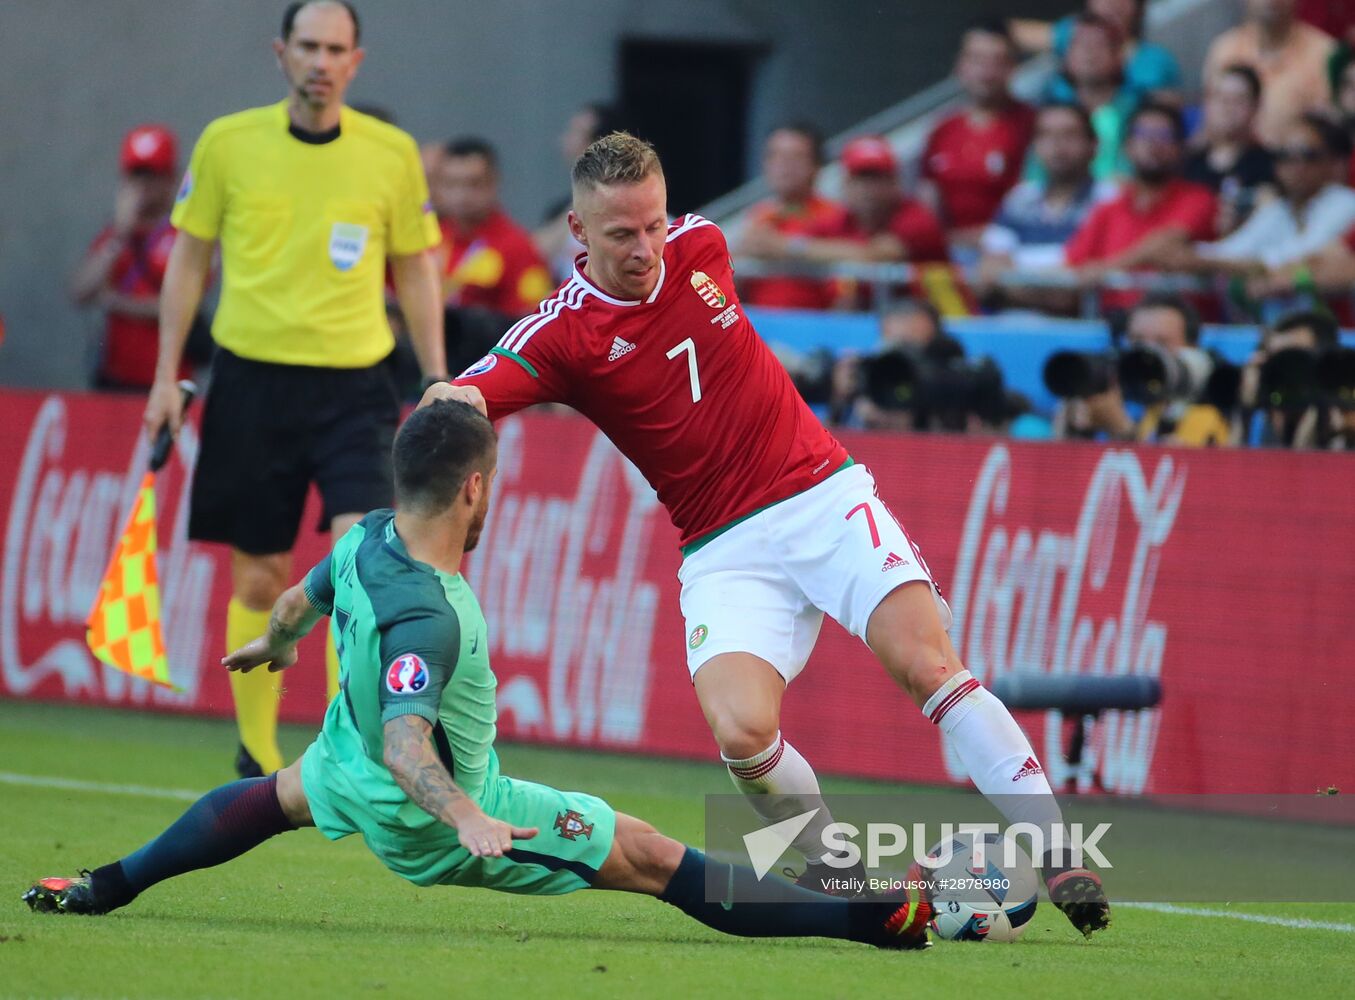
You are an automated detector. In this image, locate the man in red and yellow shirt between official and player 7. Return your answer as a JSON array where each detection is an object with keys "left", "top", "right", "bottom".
[{"left": 428, "top": 138, "right": 554, "bottom": 371}]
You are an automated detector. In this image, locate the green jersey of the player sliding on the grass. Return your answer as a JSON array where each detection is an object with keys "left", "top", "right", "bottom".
[{"left": 305, "top": 509, "right": 499, "bottom": 832}]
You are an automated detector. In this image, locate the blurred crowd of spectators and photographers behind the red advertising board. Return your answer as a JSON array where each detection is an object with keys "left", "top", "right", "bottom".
[{"left": 72, "top": 0, "right": 1355, "bottom": 449}]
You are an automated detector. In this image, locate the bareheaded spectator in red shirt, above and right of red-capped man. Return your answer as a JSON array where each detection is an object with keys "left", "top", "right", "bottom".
[{"left": 921, "top": 23, "right": 1035, "bottom": 247}]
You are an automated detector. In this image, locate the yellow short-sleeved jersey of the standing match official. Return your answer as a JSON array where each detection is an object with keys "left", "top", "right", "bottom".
[{"left": 171, "top": 102, "right": 439, "bottom": 369}]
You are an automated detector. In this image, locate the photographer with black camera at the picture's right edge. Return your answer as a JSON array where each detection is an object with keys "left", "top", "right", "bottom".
[{"left": 1238, "top": 310, "right": 1355, "bottom": 450}]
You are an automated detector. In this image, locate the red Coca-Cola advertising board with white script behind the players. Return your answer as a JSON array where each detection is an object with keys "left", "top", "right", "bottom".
[{"left": 0, "top": 392, "right": 1355, "bottom": 794}]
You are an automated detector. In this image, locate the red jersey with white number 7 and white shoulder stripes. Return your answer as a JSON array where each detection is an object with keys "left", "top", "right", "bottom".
[{"left": 455, "top": 215, "right": 847, "bottom": 545}]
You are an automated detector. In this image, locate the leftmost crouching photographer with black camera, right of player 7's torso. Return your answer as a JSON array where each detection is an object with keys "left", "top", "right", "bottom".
[{"left": 831, "top": 299, "right": 1028, "bottom": 432}]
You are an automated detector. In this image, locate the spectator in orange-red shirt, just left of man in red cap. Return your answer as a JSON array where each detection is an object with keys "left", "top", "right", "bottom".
[{"left": 734, "top": 122, "right": 846, "bottom": 309}]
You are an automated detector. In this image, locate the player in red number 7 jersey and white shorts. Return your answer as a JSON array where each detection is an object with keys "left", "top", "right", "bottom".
[{"left": 424, "top": 133, "right": 1108, "bottom": 932}]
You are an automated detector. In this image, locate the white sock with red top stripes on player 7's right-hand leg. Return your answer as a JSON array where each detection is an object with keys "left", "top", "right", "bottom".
[{"left": 923, "top": 671, "right": 1064, "bottom": 850}]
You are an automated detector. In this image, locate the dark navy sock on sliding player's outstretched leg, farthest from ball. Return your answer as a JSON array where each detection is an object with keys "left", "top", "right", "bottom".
[{"left": 92, "top": 774, "right": 295, "bottom": 907}]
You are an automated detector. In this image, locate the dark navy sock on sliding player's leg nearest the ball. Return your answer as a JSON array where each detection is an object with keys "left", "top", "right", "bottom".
[{"left": 659, "top": 847, "right": 898, "bottom": 944}]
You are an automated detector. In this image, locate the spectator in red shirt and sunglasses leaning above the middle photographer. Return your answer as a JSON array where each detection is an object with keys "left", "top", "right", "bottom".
[{"left": 1065, "top": 102, "right": 1218, "bottom": 309}]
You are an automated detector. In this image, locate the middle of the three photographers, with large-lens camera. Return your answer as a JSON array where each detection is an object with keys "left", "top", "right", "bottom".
[{"left": 1045, "top": 288, "right": 1238, "bottom": 447}]
